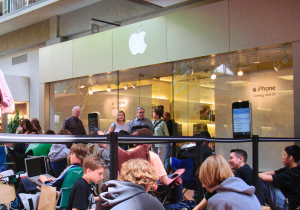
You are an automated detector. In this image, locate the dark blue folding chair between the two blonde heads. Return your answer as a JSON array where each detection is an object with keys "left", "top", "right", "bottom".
[{"left": 170, "top": 157, "right": 197, "bottom": 200}]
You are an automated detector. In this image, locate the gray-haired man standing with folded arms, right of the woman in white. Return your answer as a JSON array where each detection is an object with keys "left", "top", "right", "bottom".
[{"left": 128, "top": 107, "right": 153, "bottom": 135}]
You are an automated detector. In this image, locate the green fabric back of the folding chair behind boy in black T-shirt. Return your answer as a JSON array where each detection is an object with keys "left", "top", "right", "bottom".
[{"left": 56, "top": 167, "right": 83, "bottom": 209}]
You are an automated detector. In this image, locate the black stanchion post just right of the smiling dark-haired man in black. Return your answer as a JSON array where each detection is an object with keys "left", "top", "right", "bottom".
[{"left": 252, "top": 135, "right": 259, "bottom": 197}]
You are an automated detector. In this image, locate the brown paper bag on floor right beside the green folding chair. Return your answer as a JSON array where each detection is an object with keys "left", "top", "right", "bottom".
[{"left": 38, "top": 185, "right": 56, "bottom": 210}]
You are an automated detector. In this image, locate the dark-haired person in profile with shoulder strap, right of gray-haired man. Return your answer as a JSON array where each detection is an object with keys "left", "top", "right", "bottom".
[{"left": 151, "top": 109, "right": 169, "bottom": 163}]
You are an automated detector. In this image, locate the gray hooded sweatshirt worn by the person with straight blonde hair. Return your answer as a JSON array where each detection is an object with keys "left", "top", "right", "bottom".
[{"left": 207, "top": 177, "right": 261, "bottom": 210}]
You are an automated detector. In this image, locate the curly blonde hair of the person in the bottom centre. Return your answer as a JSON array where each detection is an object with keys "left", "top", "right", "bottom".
[{"left": 118, "top": 158, "right": 158, "bottom": 189}]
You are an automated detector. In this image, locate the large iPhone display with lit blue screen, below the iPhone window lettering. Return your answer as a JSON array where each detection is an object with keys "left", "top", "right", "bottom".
[{"left": 232, "top": 101, "right": 251, "bottom": 138}]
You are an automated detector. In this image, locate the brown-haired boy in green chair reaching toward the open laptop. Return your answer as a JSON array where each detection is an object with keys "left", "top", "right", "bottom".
[{"left": 17, "top": 144, "right": 90, "bottom": 194}]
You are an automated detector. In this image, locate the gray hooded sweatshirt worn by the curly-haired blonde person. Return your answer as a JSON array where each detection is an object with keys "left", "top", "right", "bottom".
[{"left": 96, "top": 180, "right": 165, "bottom": 210}]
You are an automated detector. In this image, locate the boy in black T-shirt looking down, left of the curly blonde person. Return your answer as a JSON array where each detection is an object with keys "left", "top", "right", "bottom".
[{"left": 67, "top": 155, "right": 105, "bottom": 210}]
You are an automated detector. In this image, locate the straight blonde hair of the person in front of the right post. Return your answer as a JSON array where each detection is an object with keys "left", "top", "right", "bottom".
[{"left": 199, "top": 155, "right": 234, "bottom": 188}]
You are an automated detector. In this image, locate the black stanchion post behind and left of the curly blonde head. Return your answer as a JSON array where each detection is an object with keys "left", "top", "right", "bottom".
[{"left": 107, "top": 132, "right": 118, "bottom": 180}]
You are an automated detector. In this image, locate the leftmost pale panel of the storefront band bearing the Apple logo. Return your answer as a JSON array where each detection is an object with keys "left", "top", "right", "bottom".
[{"left": 39, "top": 41, "right": 72, "bottom": 83}]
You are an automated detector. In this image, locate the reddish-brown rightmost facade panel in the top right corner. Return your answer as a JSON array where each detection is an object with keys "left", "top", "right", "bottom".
[{"left": 229, "top": 0, "right": 300, "bottom": 51}]
